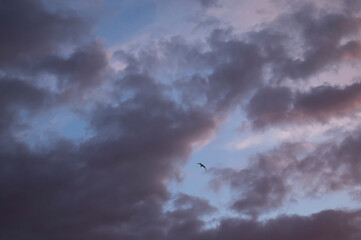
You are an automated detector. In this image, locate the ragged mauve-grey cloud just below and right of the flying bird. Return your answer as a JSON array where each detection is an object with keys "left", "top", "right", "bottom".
[{"left": 210, "top": 148, "right": 290, "bottom": 218}]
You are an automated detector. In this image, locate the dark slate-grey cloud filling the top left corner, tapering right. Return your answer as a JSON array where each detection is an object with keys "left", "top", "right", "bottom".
[{"left": 0, "top": 0, "right": 90, "bottom": 70}]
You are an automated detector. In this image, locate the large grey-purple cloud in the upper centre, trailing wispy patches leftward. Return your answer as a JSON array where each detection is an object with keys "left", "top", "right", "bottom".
[{"left": 115, "top": 29, "right": 266, "bottom": 113}]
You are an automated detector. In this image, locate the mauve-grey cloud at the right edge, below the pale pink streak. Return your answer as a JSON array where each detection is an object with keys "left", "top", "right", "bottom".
[{"left": 296, "top": 129, "right": 361, "bottom": 193}]
